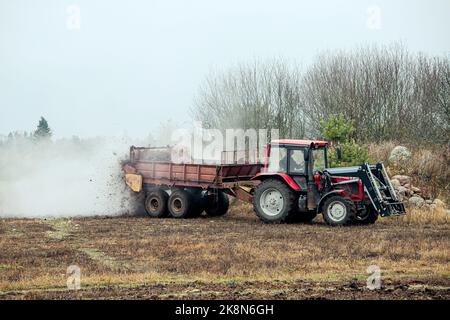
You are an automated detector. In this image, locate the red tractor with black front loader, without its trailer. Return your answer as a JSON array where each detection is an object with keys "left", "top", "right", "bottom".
[{"left": 253, "top": 140, "right": 405, "bottom": 225}]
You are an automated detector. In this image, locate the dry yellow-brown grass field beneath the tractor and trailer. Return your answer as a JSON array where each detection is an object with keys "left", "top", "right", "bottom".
[{"left": 0, "top": 203, "right": 450, "bottom": 298}]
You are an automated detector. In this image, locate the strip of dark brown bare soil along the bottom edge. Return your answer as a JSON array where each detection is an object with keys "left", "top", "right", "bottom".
[{"left": 3, "top": 280, "right": 450, "bottom": 300}]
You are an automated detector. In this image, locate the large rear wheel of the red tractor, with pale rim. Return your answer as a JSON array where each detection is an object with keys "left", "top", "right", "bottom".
[{"left": 253, "top": 179, "right": 298, "bottom": 223}]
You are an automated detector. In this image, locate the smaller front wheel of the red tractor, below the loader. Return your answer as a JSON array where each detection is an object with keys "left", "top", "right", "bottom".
[{"left": 322, "top": 196, "right": 356, "bottom": 226}]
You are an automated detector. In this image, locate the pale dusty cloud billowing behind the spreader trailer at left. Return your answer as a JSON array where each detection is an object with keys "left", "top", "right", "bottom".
[{"left": 0, "top": 138, "right": 134, "bottom": 218}]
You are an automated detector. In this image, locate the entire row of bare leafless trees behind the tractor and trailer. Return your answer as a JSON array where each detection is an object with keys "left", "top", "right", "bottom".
[{"left": 192, "top": 44, "right": 450, "bottom": 143}]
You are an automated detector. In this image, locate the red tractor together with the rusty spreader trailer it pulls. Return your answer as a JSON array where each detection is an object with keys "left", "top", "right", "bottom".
[{"left": 124, "top": 140, "right": 405, "bottom": 226}]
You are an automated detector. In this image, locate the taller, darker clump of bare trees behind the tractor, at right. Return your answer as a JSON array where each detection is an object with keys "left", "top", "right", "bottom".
[{"left": 301, "top": 44, "right": 450, "bottom": 142}]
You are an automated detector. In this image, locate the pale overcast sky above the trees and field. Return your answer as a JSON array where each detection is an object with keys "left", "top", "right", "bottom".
[{"left": 0, "top": 0, "right": 450, "bottom": 137}]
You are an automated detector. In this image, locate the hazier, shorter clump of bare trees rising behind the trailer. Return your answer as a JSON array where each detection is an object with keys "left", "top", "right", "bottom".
[{"left": 192, "top": 60, "right": 305, "bottom": 137}]
